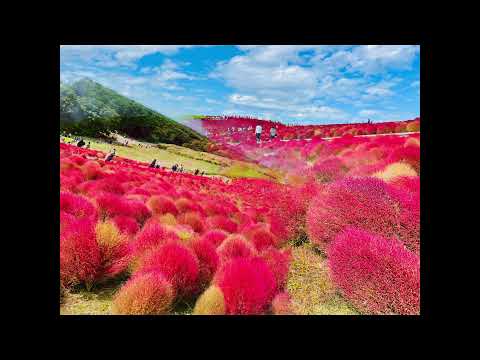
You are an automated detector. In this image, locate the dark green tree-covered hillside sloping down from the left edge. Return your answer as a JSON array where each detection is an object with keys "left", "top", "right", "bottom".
[{"left": 60, "top": 79, "right": 208, "bottom": 150}]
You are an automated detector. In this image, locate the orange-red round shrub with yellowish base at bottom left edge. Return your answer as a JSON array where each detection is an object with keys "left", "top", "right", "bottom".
[{"left": 113, "top": 271, "right": 175, "bottom": 315}]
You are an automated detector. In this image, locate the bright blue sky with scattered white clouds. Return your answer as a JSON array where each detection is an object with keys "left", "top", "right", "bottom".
[{"left": 60, "top": 45, "right": 420, "bottom": 124}]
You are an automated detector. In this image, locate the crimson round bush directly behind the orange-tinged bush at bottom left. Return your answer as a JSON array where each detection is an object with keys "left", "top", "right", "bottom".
[{"left": 139, "top": 242, "right": 199, "bottom": 297}]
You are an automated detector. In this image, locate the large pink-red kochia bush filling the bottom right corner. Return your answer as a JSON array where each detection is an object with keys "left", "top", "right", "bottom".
[{"left": 328, "top": 228, "right": 420, "bottom": 315}]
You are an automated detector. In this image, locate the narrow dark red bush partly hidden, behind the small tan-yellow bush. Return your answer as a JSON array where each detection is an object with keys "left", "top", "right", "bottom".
[{"left": 191, "top": 239, "right": 219, "bottom": 290}]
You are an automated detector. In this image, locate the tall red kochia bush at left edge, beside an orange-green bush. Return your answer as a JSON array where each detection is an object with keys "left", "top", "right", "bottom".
[{"left": 60, "top": 218, "right": 102, "bottom": 289}]
